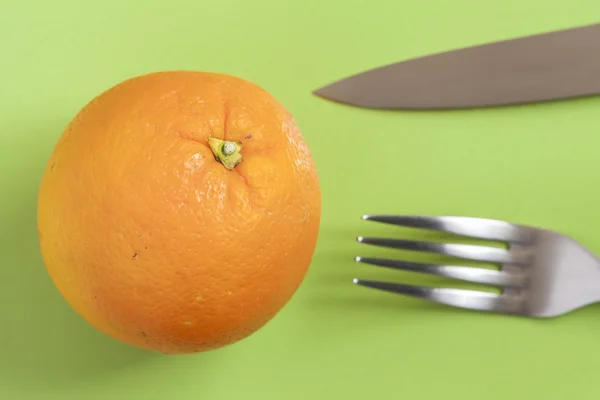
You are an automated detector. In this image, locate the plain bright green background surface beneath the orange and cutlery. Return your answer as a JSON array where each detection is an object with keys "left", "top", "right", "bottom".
[{"left": 0, "top": 0, "right": 600, "bottom": 400}]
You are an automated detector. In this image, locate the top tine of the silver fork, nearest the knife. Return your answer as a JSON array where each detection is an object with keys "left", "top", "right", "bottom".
[{"left": 363, "top": 215, "right": 531, "bottom": 243}]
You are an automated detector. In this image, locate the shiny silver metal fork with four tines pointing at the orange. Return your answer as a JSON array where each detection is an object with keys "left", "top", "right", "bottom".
[{"left": 353, "top": 215, "right": 600, "bottom": 317}]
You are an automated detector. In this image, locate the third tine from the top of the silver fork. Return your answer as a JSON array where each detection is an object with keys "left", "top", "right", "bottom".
[{"left": 356, "top": 257, "right": 525, "bottom": 288}]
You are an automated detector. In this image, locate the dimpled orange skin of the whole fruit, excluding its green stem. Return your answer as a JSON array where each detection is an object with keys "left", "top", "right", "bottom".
[{"left": 38, "top": 71, "right": 321, "bottom": 354}]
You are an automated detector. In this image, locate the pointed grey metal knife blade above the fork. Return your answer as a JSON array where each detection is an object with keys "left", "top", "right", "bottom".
[{"left": 314, "top": 24, "right": 600, "bottom": 110}]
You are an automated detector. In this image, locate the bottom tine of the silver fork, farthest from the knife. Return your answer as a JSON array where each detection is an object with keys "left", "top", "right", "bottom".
[{"left": 353, "top": 279, "right": 523, "bottom": 313}]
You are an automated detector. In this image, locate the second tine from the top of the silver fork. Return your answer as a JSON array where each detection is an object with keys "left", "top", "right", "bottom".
[{"left": 357, "top": 236, "right": 525, "bottom": 265}]
